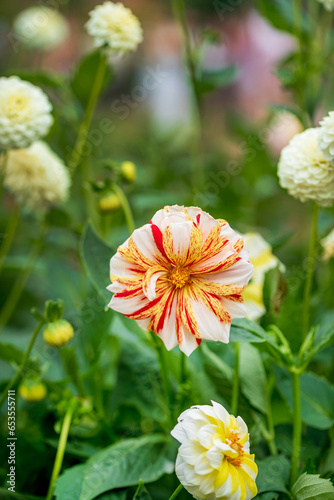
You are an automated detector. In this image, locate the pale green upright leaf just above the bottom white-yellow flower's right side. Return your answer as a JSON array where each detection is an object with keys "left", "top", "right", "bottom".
[{"left": 239, "top": 344, "right": 268, "bottom": 413}]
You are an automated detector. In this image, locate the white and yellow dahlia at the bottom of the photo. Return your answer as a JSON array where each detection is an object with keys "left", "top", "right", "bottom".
[{"left": 171, "top": 401, "right": 258, "bottom": 500}]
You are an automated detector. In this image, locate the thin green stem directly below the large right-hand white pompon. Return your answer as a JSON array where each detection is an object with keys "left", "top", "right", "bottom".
[{"left": 303, "top": 203, "right": 319, "bottom": 338}]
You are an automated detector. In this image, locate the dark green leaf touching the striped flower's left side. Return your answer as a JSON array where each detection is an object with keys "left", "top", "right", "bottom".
[{"left": 80, "top": 222, "right": 115, "bottom": 304}]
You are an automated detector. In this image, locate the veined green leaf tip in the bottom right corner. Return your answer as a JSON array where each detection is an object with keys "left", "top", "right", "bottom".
[{"left": 292, "top": 472, "right": 334, "bottom": 500}]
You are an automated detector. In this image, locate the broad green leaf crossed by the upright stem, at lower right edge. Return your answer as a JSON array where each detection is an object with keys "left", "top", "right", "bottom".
[{"left": 275, "top": 367, "right": 334, "bottom": 429}]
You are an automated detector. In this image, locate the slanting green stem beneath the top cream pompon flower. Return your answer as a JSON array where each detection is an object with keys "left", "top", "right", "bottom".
[{"left": 68, "top": 53, "right": 107, "bottom": 172}]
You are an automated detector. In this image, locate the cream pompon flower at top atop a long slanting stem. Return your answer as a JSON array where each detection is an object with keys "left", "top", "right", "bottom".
[{"left": 86, "top": 2, "right": 143, "bottom": 54}]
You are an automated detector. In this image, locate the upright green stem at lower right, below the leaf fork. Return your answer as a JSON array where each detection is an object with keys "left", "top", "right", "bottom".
[{"left": 290, "top": 373, "right": 302, "bottom": 486}]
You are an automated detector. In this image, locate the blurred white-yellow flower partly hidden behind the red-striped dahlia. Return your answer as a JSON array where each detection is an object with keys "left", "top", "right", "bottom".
[{"left": 243, "top": 233, "right": 284, "bottom": 321}]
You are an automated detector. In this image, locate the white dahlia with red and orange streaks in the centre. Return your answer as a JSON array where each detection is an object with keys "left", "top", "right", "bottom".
[{"left": 108, "top": 206, "right": 253, "bottom": 356}]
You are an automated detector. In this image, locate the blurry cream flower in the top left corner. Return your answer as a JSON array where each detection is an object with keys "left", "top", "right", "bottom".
[{"left": 13, "top": 5, "right": 69, "bottom": 51}]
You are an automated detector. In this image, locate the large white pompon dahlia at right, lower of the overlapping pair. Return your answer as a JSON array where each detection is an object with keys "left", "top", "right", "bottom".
[{"left": 278, "top": 128, "right": 334, "bottom": 206}]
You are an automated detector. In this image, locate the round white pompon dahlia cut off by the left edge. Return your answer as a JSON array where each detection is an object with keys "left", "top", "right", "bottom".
[{"left": 0, "top": 76, "right": 53, "bottom": 150}]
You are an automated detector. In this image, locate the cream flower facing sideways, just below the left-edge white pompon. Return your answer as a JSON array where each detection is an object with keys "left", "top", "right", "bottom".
[{"left": 4, "top": 141, "right": 70, "bottom": 212}]
